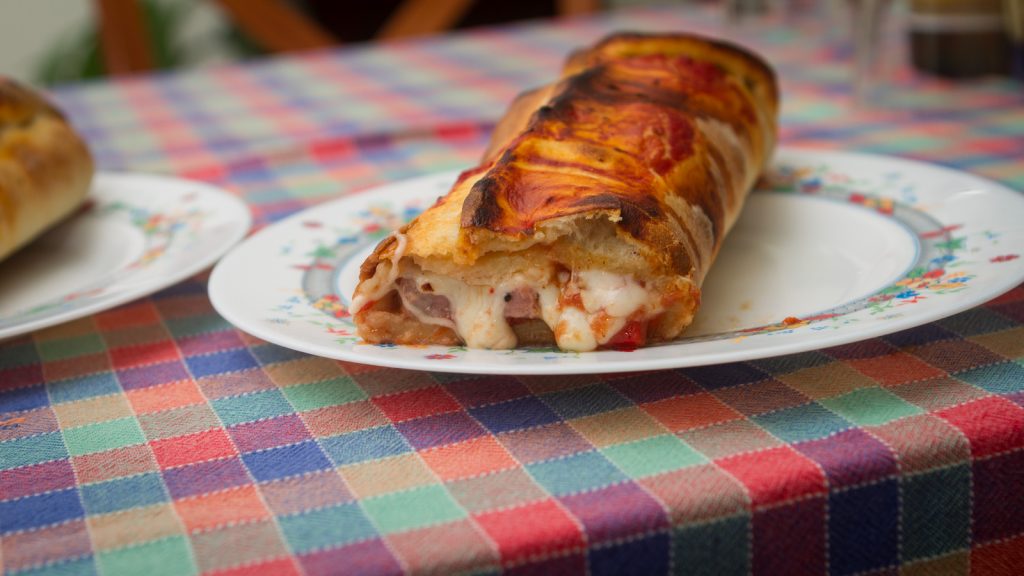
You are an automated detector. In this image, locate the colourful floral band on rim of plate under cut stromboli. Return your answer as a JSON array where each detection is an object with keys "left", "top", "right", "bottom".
[{"left": 267, "top": 164, "right": 1019, "bottom": 360}]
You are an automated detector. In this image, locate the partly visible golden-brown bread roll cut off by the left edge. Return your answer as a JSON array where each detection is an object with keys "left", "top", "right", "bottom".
[{"left": 0, "top": 78, "right": 93, "bottom": 259}]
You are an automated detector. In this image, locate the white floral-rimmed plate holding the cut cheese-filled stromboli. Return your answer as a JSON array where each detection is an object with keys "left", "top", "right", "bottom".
[{"left": 210, "top": 150, "right": 1024, "bottom": 374}]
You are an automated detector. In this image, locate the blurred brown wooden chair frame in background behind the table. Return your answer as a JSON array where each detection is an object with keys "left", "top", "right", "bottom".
[{"left": 93, "top": 0, "right": 600, "bottom": 76}]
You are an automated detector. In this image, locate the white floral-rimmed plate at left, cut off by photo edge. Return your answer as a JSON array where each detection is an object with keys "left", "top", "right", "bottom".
[{"left": 0, "top": 172, "right": 251, "bottom": 338}]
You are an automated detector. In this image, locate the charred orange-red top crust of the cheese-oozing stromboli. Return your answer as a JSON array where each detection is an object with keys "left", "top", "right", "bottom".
[{"left": 460, "top": 34, "right": 777, "bottom": 275}]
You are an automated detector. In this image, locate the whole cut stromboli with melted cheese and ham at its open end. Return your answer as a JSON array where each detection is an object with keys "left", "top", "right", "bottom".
[{"left": 351, "top": 34, "right": 778, "bottom": 351}]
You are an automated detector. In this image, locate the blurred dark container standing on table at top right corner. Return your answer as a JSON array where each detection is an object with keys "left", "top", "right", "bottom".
[{"left": 908, "top": 0, "right": 1010, "bottom": 78}]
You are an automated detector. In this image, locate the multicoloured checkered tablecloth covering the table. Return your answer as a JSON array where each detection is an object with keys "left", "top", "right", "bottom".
[{"left": 0, "top": 8, "right": 1024, "bottom": 576}]
